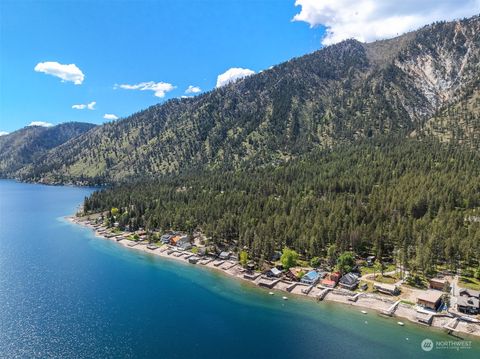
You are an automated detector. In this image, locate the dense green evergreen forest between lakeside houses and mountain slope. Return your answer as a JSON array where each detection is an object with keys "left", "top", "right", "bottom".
[{"left": 84, "top": 138, "right": 480, "bottom": 273}]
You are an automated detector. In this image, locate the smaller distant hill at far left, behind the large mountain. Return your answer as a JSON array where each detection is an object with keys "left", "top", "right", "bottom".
[{"left": 0, "top": 122, "right": 95, "bottom": 177}]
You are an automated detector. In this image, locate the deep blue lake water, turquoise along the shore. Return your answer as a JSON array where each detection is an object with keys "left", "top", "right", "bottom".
[{"left": 0, "top": 181, "right": 480, "bottom": 359}]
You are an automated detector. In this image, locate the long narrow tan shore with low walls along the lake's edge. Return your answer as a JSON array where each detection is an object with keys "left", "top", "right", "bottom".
[{"left": 65, "top": 216, "right": 480, "bottom": 338}]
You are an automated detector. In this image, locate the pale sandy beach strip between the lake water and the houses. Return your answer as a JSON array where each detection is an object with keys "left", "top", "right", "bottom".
[{"left": 64, "top": 216, "right": 480, "bottom": 339}]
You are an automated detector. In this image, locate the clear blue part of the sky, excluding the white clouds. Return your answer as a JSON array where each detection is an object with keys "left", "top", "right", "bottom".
[{"left": 0, "top": 0, "right": 323, "bottom": 132}]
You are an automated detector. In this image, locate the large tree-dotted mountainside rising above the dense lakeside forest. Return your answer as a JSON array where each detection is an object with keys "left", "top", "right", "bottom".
[{"left": 9, "top": 16, "right": 480, "bottom": 183}]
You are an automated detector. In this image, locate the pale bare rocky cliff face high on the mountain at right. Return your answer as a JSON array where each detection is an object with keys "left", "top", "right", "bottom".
[{"left": 394, "top": 17, "right": 480, "bottom": 118}]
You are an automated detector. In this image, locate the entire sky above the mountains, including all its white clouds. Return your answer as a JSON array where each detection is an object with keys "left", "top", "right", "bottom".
[{"left": 0, "top": 0, "right": 480, "bottom": 134}]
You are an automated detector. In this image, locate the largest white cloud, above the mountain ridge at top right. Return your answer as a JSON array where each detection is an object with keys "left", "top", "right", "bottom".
[{"left": 293, "top": 0, "right": 480, "bottom": 45}]
